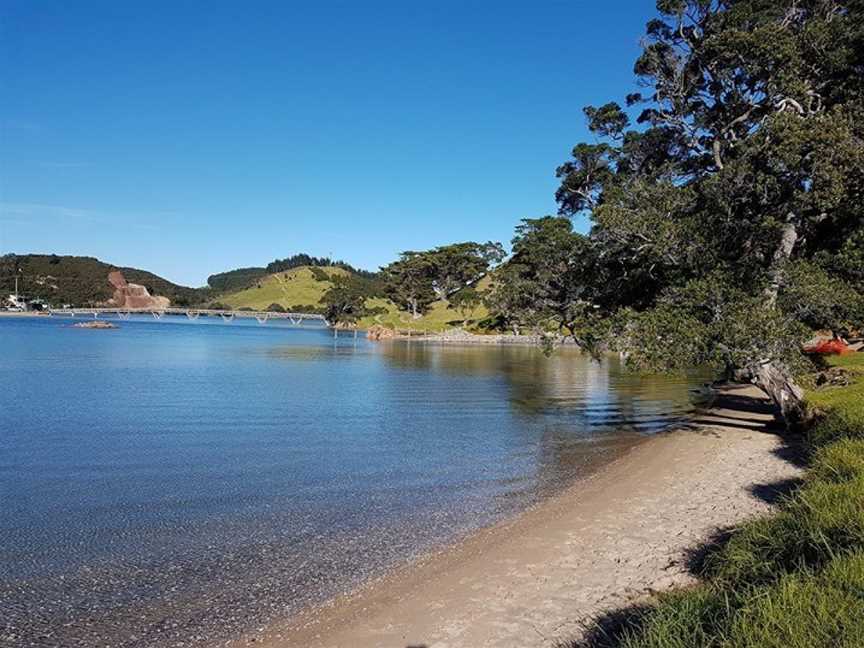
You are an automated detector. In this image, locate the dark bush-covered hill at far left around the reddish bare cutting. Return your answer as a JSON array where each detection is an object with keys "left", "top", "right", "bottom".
[{"left": 0, "top": 254, "right": 211, "bottom": 306}]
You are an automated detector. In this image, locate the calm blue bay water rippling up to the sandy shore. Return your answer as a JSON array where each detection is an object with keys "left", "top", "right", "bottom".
[{"left": 0, "top": 318, "right": 704, "bottom": 647}]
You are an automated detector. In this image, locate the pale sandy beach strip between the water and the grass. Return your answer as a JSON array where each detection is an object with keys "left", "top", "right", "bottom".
[{"left": 230, "top": 387, "right": 801, "bottom": 648}]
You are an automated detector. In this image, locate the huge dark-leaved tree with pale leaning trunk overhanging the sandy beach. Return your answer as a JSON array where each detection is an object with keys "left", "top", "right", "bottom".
[{"left": 514, "top": 0, "right": 864, "bottom": 422}]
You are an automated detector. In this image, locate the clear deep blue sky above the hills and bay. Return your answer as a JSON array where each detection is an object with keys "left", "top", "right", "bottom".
[{"left": 0, "top": 0, "right": 653, "bottom": 285}]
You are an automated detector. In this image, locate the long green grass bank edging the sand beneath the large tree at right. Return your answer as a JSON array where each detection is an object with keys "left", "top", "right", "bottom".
[{"left": 584, "top": 354, "right": 864, "bottom": 648}]
